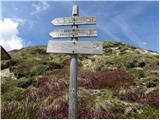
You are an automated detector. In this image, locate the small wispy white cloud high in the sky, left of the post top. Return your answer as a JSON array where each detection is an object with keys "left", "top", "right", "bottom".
[{"left": 31, "top": 1, "right": 50, "bottom": 15}]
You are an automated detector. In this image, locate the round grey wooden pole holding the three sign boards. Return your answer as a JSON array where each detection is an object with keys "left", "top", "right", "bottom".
[{"left": 69, "top": 5, "right": 79, "bottom": 119}]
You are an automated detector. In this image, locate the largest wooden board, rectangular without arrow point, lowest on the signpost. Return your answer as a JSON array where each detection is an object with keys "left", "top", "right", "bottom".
[{"left": 47, "top": 40, "right": 103, "bottom": 54}]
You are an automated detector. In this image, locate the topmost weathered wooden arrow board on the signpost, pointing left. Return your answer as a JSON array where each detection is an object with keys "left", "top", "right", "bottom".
[{"left": 52, "top": 17, "right": 96, "bottom": 25}]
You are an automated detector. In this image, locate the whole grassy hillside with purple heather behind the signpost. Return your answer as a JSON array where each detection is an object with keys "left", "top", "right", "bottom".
[{"left": 1, "top": 42, "right": 159, "bottom": 119}]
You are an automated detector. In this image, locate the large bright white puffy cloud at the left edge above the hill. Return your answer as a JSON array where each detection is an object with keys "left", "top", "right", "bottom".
[{"left": 0, "top": 18, "right": 24, "bottom": 51}]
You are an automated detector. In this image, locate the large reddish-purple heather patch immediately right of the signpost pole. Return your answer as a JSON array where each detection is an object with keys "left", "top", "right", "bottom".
[{"left": 81, "top": 70, "right": 133, "bottom": 89}]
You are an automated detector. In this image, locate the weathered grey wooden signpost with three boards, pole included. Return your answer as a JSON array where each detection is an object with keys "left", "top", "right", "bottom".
[{"left": 47, "top": 5, "right": 103, "bottom": 119}]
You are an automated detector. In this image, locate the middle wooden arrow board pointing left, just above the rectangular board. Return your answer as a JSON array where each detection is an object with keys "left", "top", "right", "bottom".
[{"left": 50, "top": 28, "right": 97, "bottom": 38}]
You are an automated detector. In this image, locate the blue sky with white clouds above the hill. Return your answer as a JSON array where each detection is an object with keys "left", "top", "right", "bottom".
[{"left": 0, "top": 0, "right": 159, "bottom": 51}]
